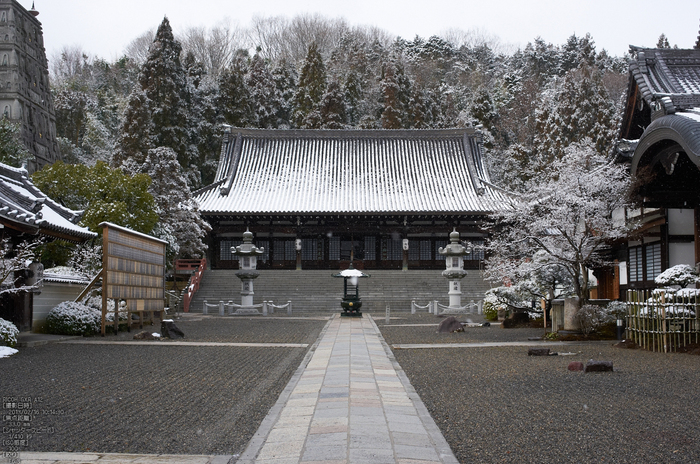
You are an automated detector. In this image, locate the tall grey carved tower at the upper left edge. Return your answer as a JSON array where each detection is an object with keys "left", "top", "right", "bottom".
[{"left": 0, "top": 0, "right": 60, "bottom": 172}]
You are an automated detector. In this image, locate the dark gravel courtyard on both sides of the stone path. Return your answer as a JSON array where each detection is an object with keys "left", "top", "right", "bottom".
[{"left": 0, "top": 312, "right": 700, "bottom": 463}]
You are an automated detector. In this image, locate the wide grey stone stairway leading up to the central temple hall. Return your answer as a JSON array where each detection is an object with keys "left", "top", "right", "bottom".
[{"left": 190, "top": 270, "right": 489, "bottom": 313}]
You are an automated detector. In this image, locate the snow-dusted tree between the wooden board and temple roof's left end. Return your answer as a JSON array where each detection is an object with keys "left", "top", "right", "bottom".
[{"left": 142, "top": 147, "right": 211, "bottom": 258}]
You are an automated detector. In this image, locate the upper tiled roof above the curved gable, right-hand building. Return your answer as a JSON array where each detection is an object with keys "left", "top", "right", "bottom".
[{"left": 630, "top": 47, "right": 700, "bottom": 110}]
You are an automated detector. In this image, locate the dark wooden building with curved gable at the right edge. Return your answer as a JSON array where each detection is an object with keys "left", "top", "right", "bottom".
[{"left": 616, "top": 40, "right": 700, "bottom": 297}]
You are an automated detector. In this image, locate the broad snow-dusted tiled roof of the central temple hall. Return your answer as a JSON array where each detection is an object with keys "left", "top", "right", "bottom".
[{"left": 197, "top": 128, "right": 507, "bottom": 215}]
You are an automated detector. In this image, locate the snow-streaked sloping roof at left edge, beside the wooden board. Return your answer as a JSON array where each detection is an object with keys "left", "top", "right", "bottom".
[{"left": 0, "top": 163, "right": 97, "bottom": 241}]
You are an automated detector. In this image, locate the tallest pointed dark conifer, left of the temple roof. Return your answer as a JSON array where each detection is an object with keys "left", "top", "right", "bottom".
[{"left": 139, "top": 18, "right": 190, "bottom": 167}]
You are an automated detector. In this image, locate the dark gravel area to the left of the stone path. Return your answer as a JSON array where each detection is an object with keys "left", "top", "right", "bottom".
[{"left": 0, "top": 317, "right": 327, "bottom": 454}]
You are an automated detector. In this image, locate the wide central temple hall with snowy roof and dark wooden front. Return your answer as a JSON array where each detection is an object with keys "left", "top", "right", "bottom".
[{"left": 196, "top": 128, "right": 508, "bottom": 270}]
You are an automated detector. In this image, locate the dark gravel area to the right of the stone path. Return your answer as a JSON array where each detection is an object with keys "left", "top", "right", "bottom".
[{"left": 376, "top": 314, "right": 700, "bottom": 463}]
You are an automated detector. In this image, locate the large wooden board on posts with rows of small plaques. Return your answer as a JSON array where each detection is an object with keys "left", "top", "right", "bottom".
[{"left": 100, "top": 222, "right": 167, "bottom": 335}]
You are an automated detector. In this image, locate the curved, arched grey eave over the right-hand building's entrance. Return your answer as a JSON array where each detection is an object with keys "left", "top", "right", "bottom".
[{"left": 630, "top": 113, "right": 700, "bottom": 175}]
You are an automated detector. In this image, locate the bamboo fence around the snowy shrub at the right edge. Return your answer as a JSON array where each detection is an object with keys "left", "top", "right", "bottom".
[{"left": 627, "top": 289, "right": 700, "bottom": 353}]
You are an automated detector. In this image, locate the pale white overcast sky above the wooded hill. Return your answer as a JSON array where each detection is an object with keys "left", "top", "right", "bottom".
[{"left": 19, "top": 0, "right": 700, "bottom": 60}]
